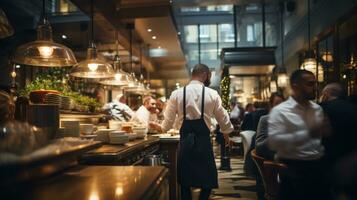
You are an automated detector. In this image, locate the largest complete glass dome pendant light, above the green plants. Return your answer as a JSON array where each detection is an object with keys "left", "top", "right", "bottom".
[{"left": 12, "top": 0, "right": 77, "bottom": 67}]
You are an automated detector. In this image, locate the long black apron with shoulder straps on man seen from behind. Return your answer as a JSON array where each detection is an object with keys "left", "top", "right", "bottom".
[{"left": 177, "top": 86, "right": 218, "bottom": 188}]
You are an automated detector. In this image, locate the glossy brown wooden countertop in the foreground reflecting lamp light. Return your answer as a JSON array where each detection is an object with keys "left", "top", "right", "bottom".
[{"left": 0, "top": 165, "right": 168, "bottom": 200}]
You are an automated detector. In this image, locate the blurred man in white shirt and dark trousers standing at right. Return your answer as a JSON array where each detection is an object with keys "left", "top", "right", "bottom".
[{"left": 268, "top": 70, "right": 323, "bottom": 200}]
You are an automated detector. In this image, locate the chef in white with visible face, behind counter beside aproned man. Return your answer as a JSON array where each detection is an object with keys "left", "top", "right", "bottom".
[{"left": 131, "top": 96, "right": 157, "bottom": 126}]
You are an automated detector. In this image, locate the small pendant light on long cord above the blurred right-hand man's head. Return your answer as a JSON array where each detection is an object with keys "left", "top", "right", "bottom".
[{"left": 277, "top": 2, "right": 289, "bottom": 88}]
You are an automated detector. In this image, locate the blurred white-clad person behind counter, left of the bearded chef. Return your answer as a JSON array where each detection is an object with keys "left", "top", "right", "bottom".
[{"left": 103, "top": 94, "right": 135, "bottom": 121}]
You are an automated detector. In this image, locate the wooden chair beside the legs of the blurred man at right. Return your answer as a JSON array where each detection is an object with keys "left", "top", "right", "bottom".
[{"left": 251, "top": 149, "right": 286, "bottom": 200}]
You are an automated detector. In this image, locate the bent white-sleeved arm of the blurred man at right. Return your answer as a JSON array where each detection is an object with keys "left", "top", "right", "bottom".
[{"left": 268, "top": 109, "right": 309, "bottom": 152}]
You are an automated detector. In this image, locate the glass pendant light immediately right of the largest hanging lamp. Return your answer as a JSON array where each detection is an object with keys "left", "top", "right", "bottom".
[{"left": 70, "top": 0, "right": 114, "bottom": 79}]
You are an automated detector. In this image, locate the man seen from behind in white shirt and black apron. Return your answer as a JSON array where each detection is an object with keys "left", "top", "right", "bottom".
[{"left": 149, "top": 64, "right": 233, "bottom": 200}]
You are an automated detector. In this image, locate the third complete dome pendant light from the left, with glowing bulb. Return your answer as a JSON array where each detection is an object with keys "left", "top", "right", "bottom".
[{"left": 100, "top": 30, "right": 131, "bottom": 87}]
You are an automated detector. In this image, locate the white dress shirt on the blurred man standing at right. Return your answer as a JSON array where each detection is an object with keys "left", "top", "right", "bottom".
[{"left": 268, "top": 97, "right": 323, "bottom": 160}]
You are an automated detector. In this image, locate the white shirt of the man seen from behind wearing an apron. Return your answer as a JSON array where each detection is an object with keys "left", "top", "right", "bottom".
[{"left": 161, "top": 80, "right": 233, "bottom": 133}]
